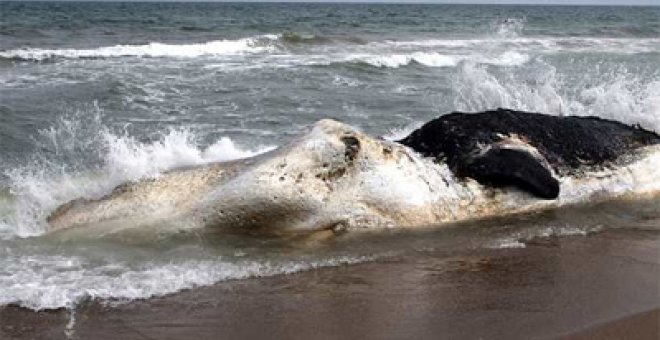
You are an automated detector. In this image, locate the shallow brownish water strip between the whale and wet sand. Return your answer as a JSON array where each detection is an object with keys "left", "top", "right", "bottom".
[{"left": 0, "top": 193, "right": 660, "bottom": 309}]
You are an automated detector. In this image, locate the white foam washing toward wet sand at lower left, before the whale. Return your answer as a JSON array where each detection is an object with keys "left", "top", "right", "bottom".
[{"left": 0, "top": 255, "right": 373, "bottom": 310}]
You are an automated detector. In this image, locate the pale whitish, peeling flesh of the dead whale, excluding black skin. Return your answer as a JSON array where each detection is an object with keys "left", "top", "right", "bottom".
[{"left": 45, "top": 119, "right": 660, "bottom": 231}]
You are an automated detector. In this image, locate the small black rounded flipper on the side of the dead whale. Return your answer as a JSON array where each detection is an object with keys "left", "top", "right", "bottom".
[{"left": 461, "top": 148, "right": 559, "bottom": 199}]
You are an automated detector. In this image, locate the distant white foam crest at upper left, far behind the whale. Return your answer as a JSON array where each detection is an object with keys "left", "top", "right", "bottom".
[{"left": 0, "top": 35, "right": 278, "bottom": 61}]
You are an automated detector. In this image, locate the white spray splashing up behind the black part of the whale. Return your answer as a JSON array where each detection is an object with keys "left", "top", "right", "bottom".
[{"left": 452, "top": 60, "right": 660, "bottom": 131}]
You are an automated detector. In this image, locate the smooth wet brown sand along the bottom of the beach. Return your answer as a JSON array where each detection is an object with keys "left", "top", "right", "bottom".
[{"left": 0, "top": 229, "right": 660, "bottom": 339}]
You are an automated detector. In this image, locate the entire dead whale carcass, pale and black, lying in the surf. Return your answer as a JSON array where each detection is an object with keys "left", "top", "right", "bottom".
[{"left": 47, "top": 109, "right": 660, "bottom": 233}]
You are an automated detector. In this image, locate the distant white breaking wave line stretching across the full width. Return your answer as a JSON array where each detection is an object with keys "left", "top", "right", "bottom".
[{"left": 0, "top": 33, "right": 660, "bottom": 67}]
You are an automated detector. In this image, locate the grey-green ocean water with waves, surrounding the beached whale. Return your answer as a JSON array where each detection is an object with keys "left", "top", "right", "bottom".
[{"left": 0, "top": 2, "right": 660, "bottom": 309}]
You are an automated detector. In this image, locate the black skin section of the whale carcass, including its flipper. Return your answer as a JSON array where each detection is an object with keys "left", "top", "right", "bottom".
[{"left": 399, "top": 109, "right": 660, "bottom": 198}]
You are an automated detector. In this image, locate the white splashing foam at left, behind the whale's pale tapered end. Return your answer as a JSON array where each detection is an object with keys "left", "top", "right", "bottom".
[{"left": 0, "top": 108, "right": 274, "bottom": 237}]
